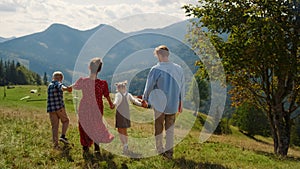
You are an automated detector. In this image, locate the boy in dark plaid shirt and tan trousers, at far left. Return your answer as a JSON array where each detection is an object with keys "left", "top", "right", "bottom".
[{"left": 47, "top": 71, "right": 72, "bottom": 149}]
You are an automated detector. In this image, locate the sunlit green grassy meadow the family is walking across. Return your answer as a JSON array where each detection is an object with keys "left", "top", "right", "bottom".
[{"left": 0, "top": 86, "right": 300, "bottom": 169}]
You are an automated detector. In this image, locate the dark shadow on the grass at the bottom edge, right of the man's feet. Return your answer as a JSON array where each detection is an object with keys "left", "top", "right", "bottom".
[{"left": 173, "top": 157, "right": 227, "bottom": 169}]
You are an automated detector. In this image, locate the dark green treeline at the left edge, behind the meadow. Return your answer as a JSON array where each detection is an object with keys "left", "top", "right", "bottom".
[{"left": 0, "top": 59, "right": 43, "bottom": 86}]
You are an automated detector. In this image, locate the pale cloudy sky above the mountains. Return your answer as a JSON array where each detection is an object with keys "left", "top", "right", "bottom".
[{"left": 0, "top": 0, "right": 197, "bottom": 38}]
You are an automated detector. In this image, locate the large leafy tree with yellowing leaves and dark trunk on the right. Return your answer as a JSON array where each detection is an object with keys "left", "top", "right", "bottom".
[{"left": 183, "top": 0, "right": 300, "bottom": 156}]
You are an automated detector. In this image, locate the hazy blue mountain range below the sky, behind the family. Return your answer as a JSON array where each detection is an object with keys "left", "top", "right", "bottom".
[{"left": 0, "top": 20, "right": 216, "bottom": 85}]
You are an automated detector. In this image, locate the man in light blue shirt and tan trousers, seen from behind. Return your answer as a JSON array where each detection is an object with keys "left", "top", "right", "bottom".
[{"left": 143, "top": 45, "right": 185, "bottom": 159}]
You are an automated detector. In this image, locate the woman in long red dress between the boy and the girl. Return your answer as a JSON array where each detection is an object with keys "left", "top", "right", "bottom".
[{"left": 73, "top": 58, "right": 114, "bottom": 157}]
